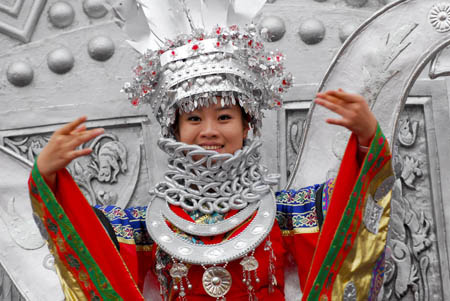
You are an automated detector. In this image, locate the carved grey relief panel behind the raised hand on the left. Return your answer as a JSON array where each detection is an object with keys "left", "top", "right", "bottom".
[{"left": 2, "top": 117, "right": 149, "bottom": 208}]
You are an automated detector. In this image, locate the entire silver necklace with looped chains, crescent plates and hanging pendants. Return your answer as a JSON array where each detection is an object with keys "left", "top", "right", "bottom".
[{"left": 146, "top": 138, "right": 278, "bottom": 300}]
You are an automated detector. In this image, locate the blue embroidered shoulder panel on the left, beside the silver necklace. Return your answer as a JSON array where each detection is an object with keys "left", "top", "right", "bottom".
[{"left": 95, "top": 206, "right": 153, "bottom": 245}]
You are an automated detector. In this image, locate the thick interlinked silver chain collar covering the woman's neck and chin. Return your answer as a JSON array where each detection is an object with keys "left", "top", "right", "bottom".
[{"left": 154, "top": 138, "right": 279, "bottom": 214}]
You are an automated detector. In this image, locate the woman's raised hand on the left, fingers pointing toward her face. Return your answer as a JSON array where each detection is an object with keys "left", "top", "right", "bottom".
[{"left": 36, "top": 116, "right": 105, "bottom": 189}]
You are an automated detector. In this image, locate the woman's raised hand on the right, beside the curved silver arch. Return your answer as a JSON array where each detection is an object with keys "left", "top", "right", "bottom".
[{"left": 315, "top": 89, "right": 377, "bottom": 146}]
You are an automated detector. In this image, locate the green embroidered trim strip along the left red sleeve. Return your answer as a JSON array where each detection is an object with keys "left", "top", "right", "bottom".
[{"left": 31, "top": 164, "right": 122, "bottom": 300}]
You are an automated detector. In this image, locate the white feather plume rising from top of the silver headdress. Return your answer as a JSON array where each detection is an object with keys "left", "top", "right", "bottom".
[{"left": 113, "top": 0, "right": 266, "bottom": 54}]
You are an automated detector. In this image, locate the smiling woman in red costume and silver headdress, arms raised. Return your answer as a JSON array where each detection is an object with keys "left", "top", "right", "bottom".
[{"left": 29, "top": 0, "right": 392, "bottom": 301}]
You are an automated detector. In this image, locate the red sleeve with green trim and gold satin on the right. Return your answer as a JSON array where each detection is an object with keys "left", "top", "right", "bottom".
[{"left": 281, "top": 123, "right": 393, "bottom": 300}]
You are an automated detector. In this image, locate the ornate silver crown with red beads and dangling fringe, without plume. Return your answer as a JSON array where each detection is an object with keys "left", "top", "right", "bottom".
[{"left": 123, "top": 24, "right": 292, "bottom": 137}]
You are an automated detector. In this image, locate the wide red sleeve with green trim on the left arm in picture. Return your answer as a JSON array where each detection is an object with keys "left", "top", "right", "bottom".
[{"left": 29, "top": 165, "right": 143, "bottom": 300}]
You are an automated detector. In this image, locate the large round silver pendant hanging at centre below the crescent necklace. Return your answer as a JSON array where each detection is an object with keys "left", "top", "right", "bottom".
[{"left": 202, "top": 267, "right": 231, "bottom": 298}]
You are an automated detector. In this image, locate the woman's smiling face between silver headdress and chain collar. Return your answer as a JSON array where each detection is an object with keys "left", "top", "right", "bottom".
[{"left": 176, "top": 101, "right": 249, "bottom": 154}]
